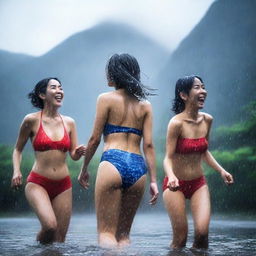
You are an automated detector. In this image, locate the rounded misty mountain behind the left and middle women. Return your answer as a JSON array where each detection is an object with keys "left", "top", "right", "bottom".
[{"left": 0, "top": 23, "right": 170, "bottom": 143}]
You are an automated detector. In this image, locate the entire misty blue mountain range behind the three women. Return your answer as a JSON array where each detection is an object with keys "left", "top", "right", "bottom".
[{"left": 0, "top": 0, "right": 256, "bottom": 146}]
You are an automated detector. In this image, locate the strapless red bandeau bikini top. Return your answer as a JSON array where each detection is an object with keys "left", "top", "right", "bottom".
[{"left": 175, "top": 138, "right": 208, "bottom": 154}]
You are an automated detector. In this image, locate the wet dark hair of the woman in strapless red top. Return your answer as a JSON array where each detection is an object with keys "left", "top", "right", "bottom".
[{"left": 172, "top": 75, "right": 203, "bottom": 114}]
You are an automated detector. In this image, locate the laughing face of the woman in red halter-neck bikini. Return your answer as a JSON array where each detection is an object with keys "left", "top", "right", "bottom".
[{"left": 40, "top": 79, "right": 64, "bottom": 107}]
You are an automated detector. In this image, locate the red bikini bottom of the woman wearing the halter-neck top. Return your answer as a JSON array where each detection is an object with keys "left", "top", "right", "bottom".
[{"left": 27, "top": 171, "right": 72, "bottom": 200}]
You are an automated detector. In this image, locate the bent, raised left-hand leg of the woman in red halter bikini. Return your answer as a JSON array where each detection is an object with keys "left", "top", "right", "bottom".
[{"left": 25, "top": 182, "right": 57, "bottom": 244}]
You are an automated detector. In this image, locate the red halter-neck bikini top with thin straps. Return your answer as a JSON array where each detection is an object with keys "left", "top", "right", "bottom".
[{"left": 32, "top": 111, "right": 70, "bottom": 152}]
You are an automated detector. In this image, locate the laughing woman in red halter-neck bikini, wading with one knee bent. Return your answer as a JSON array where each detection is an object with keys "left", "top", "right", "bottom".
[{"left": 11, "top": 78, "right": 86, "bottom": 244}]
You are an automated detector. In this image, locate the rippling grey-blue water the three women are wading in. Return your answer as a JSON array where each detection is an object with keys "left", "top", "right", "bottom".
[{"left": 0, "top": 213, "right": 256, "bottom": 256}]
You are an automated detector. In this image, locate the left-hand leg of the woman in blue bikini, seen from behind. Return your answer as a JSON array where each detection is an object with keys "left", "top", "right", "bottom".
[{"left": 95, "top": 161, "right": 122, "bottom": 247}]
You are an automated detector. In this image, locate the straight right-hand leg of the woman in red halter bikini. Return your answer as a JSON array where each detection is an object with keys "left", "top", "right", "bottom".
[{"left": 52, "top": 188, "right": 72, "bottom": 242}]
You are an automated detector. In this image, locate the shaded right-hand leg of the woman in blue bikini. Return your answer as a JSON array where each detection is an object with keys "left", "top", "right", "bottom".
[{"left": 116, "top": 175, "right": 146, "bottom": 245}]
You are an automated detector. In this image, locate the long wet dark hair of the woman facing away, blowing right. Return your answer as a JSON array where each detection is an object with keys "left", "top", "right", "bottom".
[{"left": 106, "top": 53, "right": 155, "bottom": 100}]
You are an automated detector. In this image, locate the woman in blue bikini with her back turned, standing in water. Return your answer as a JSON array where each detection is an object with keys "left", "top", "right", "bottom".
[{"left": 78, "top": 54, "right": 158, "bottom": 247}]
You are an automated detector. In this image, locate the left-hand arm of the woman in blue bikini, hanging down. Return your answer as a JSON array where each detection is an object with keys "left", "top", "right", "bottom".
[{"left": 78, "top": 94, "right": 109, "bottom": 188}]
